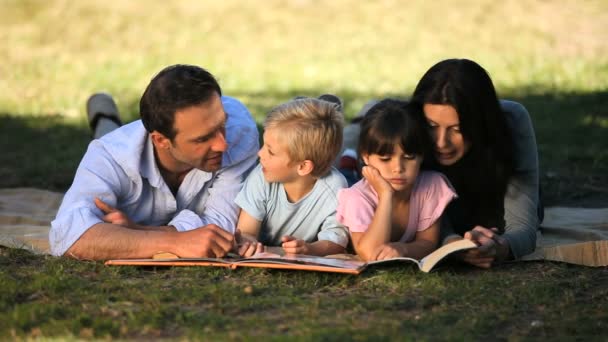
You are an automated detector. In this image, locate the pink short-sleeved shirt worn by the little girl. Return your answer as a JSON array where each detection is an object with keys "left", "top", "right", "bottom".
[{"left": 337, "top": 171, "right": 457, "bottom": 242}]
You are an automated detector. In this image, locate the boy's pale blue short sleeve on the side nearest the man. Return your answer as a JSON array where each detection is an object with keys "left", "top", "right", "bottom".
[{"left": 234, "top": 165, "right": 268, "bottom": 221}]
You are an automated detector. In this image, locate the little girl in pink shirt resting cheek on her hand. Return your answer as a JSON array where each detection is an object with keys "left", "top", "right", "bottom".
[{"left": 337, "top": 99, "right": 456, "bottom": 260}]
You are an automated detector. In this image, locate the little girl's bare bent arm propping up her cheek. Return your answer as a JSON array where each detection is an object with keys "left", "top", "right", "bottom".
[{"left": 351, "top": 166, "right": 393, "bottom": 260}]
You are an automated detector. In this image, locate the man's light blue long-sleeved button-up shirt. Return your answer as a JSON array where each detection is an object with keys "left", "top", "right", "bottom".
[{"left": 49, "top": 96, "right": 259, "bottom": 256}]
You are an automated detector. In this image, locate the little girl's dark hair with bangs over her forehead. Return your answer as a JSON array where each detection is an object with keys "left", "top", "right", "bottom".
[{"left": 357, "top": 99, "right": 432, "bottom": 162}]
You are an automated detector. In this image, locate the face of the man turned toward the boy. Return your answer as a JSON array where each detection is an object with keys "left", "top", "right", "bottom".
[{"left": 168, "top": 94, "right": 228, "bottom": 172}]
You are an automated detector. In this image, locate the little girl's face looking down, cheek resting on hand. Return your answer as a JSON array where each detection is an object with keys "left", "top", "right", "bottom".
[{"left": 362, "top": 144, "right": 422, "bottom": 191}]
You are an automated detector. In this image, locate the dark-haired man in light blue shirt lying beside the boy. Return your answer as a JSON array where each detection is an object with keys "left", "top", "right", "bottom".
[{"left": 49, "top": 65, "right": 259, "bottom": 260}]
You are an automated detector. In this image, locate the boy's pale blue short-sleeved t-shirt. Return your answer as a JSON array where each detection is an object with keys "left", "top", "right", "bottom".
[{"left": 235, "top": 165, "right": 348, "bottom": 247}]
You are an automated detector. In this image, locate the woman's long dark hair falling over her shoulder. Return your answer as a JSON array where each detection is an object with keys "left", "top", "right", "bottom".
[{"left": 412, "top": 59, "right": 514, "bottom": 232}]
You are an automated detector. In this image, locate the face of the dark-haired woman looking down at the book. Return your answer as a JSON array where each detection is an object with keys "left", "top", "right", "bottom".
[{"left": 423, "top": 104, "right": 471, "bottom": 166}]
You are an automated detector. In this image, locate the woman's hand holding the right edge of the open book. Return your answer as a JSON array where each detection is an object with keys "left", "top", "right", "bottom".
[{"left": 462, "top": 226, "right": 509, "bottom": 268}]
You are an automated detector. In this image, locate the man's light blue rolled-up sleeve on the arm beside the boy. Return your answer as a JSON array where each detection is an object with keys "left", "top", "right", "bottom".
[{"left": 192, "top": 151, "right": 257, "bottom": 233}]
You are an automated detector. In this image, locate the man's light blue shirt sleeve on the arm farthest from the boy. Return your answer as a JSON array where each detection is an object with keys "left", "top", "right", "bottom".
[{"left": 49, "top": 141, "right": 130, "bottom": 256}]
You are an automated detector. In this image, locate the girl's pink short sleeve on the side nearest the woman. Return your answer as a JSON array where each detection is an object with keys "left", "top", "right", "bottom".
[{"left": 410, "top": 172, "right": 457, "bottom": 231}]
